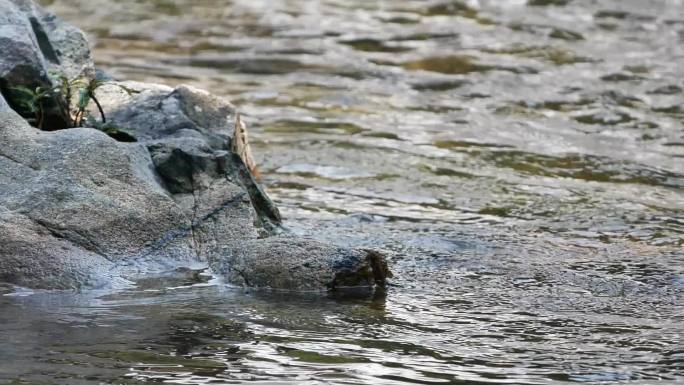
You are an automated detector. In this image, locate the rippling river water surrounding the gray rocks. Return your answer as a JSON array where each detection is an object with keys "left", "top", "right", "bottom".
[{"left": 0, "top": 0, "right": 684, "bottom": 384}]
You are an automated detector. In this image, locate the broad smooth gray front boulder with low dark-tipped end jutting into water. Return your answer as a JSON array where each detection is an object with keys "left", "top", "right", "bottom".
[{"left": 0, "top": 91, "right": 388, "bottom": 290}]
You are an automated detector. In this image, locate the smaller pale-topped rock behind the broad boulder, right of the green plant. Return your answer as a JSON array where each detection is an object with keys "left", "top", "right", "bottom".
[{"left": 90, "top": 81, "right": 281, "bottom": 235}]
